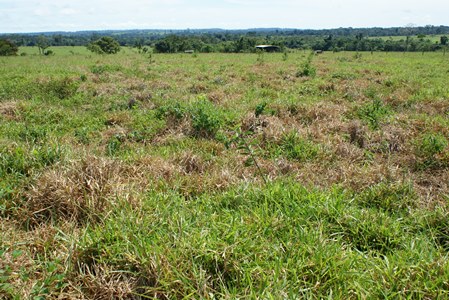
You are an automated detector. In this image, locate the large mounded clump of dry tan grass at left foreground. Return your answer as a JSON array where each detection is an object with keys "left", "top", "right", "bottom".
[{"left": 21, "top": 157, "right": 142, "bottom": 225}]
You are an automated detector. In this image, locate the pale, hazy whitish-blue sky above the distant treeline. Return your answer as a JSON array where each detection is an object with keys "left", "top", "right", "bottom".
[{"left": 0, "top": 0, "right": 449, "bottom": 33}]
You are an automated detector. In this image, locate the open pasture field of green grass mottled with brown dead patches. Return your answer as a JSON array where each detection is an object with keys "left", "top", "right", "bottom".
[{"left": 0, "top": 47, "right": 449, "bottom": 299}]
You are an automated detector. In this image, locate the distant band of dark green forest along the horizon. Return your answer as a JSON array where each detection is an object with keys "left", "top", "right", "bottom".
[{"left": 0, "top": 25, "right": 449, "bottom": 53}]
